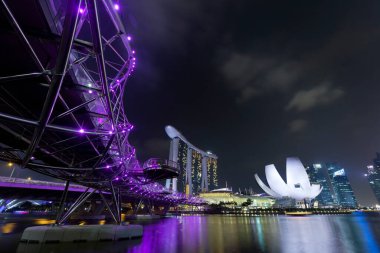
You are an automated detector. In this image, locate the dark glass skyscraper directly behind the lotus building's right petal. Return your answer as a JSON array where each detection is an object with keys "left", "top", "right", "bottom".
[{"left": 306, "top": 163, "right": 334, "bottom": 206}]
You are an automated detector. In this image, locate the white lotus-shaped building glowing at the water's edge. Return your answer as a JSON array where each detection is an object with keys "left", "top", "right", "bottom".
[{"left": 255, "top": 157, "right": 323, "bottom": 201}]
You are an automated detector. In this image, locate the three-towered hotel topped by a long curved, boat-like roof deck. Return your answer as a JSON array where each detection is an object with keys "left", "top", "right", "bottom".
[{"left": 165, "top": 126, "right": 218, "bottom": 195}]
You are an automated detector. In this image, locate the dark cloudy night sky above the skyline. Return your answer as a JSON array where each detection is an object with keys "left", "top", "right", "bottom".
[{"left": 122, "top": 0, "right": 380, "bottom": 205}]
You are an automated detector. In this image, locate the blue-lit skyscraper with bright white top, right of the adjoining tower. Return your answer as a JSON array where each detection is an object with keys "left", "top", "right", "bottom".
[{"left": 326, "top": 163, "right": 357, "bottom": 207}]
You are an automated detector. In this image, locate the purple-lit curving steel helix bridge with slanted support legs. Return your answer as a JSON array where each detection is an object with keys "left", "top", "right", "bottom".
[{"left": 0, "top": 0, "right": 205, "bottom": 223}]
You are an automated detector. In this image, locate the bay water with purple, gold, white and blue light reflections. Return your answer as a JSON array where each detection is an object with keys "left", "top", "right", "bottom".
[{"left": 0, "top": 215, "right": 380, "bottom": 253}]
